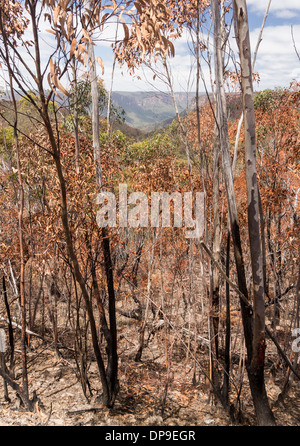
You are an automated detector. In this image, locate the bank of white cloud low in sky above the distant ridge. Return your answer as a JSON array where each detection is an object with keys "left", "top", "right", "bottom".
[{"left": 97, "top": 21, "right": 300, "bottom": 94}]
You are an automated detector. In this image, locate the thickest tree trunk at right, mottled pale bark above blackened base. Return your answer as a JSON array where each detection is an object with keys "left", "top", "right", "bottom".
[{"left": 233, "top": 0, "right": 275, "bottom": 425}]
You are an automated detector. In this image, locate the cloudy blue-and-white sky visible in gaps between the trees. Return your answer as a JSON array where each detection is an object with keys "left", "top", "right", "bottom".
[{"left": 0, "top": 0, "right": 300, "bottom": 96}]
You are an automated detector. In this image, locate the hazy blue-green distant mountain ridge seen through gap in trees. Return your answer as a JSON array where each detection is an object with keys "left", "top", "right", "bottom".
[{"left": 112, "top": 91, "right": 202, "bottom": 131}]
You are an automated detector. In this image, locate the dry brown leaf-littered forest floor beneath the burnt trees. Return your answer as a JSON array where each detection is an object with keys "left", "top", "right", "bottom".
[{"left": 0, "top": 312, "right": 300, "bottom": 426}]
